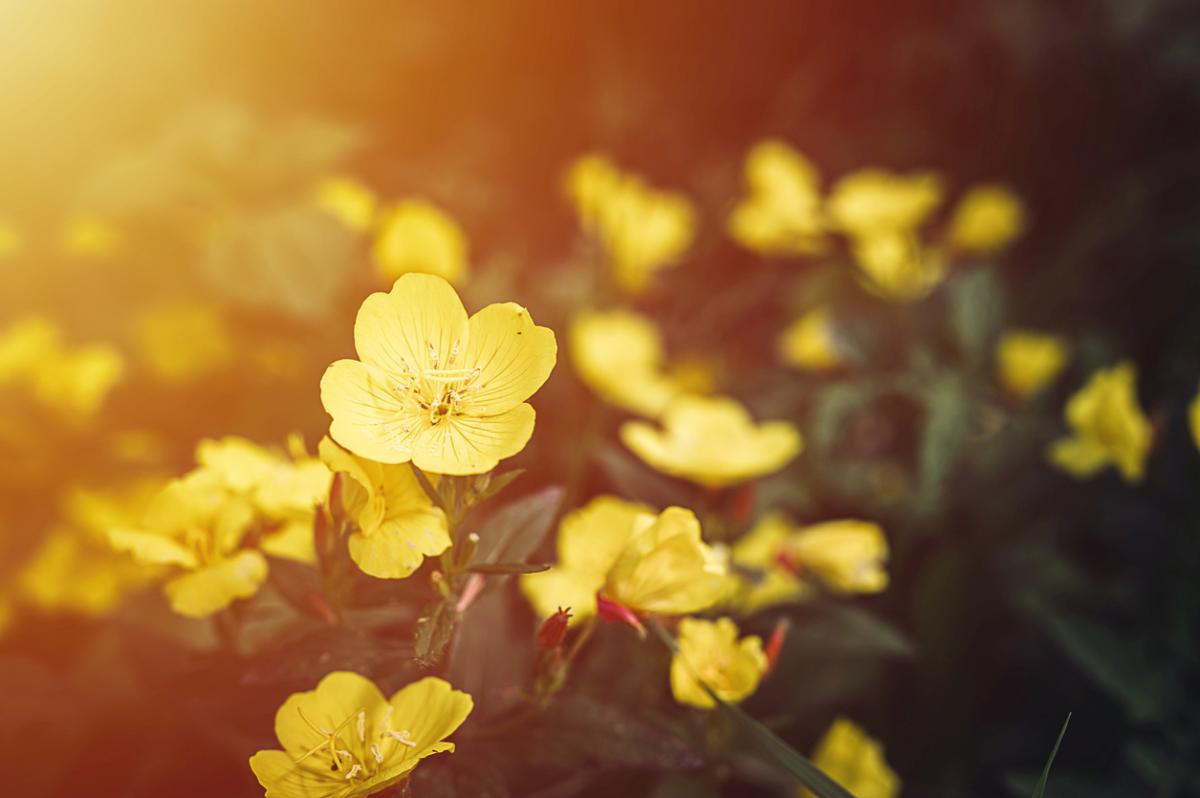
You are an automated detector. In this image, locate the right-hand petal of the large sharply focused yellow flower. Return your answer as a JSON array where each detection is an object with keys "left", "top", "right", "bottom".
[{"left": 463, "top": 302, "right": 558, "bottom": 415}]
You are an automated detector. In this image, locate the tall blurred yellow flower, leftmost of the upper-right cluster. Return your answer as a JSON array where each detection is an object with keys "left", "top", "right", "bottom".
[{"left": 728, "top": 139, "right": 826, "bottom": 256}]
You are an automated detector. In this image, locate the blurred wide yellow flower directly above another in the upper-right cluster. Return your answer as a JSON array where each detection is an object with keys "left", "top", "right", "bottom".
[{"left": 826, "top": 164, "right": 942, "bottom": 238}]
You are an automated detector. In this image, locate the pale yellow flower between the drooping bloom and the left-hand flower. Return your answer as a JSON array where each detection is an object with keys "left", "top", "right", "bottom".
[{"left": 196, "top": 436, "right": 332, "bottom": 563}]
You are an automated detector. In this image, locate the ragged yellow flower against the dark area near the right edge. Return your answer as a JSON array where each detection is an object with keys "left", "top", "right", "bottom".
[{"left": 1049, "top": 361, "right": 1152, "bottom": 482}]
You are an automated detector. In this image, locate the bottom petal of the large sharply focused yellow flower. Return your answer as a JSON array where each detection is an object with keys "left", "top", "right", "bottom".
[{"left": 413, "top": 404, "right": 535, "bottom": 474}]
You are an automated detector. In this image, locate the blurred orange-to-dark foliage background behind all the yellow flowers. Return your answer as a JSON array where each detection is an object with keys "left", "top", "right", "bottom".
[{"left": 0, "top": 0, "right": 1200, "bottom": 798}]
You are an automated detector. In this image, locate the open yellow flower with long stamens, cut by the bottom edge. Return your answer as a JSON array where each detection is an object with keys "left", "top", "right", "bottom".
[{"left": 250, "top": 671, "right": 474, "bottom": 798}]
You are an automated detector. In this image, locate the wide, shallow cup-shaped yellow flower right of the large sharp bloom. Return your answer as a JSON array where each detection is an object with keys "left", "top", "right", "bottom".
[{"left": 620, "top": 396, "right": 803, "bottom": 488}]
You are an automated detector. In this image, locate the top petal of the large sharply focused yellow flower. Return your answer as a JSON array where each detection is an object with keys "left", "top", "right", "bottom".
[{"left": 354, "top": 274, "right": 467, "bottom": 377}]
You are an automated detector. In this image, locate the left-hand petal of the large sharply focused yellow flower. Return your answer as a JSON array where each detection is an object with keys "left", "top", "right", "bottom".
[{"left": 320, "top": 360, "right": 412, "bottom": 463}]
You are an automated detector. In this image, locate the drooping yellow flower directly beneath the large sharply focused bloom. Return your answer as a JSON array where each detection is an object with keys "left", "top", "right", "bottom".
[{"left": 319, "top": 438, "right": 450, "bottom": 580}]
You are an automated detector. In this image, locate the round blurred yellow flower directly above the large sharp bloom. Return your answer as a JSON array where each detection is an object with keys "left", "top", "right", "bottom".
[{"left": 371, "top": 199, "right": 468, "bottom": 283}]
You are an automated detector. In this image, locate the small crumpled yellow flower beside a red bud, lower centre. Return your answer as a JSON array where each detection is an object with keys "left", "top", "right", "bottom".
[{"left": 671, "top": 618, "right": 767, "bottom": 709}]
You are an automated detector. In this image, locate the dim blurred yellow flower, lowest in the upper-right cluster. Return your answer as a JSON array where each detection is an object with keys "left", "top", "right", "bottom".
[{"left": 851, "top": 232, "right": 949, "bottom": 302}]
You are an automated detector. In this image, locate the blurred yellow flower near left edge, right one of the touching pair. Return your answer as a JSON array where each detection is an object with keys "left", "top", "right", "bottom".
[{"left": 32, "top": 343, "right": 125, "bottom": 422}]
